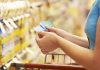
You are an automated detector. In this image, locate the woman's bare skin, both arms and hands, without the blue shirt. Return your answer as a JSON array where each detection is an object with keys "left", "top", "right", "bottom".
[{"left": 36, "top": 18, "right": 100, "bottom": 70}]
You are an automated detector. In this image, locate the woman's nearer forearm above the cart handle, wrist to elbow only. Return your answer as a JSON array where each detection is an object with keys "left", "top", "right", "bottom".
[{"left": 57, "top": 37, "right": 93, "bottom": 68}]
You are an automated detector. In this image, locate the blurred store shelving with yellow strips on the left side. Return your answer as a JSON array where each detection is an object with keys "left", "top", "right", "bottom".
[{"left": 0, "top": 0, "right": 41, "bottom": 67}]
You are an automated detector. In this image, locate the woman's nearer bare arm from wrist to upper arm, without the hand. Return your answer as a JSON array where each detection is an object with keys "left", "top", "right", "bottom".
[{"left": 57, "top": 17, "right": 100, "bottom": 70}]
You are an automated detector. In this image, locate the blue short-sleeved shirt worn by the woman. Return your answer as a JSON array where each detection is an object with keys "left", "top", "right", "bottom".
[{"left": 85, "top": 0, "right": 100, "bottom": 49}]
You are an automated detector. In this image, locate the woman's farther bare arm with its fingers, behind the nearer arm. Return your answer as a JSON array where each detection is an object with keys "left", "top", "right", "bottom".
[{"left": 47, "top": 28, "right": 89, "bottom": 48}]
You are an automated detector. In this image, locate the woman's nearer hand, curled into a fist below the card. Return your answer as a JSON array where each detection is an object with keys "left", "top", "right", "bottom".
[{"left": 36, "top": 31, "right": 58, "bottom": 53}]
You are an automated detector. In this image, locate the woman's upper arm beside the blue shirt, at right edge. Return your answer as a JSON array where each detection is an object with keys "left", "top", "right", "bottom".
[{"left": 94, "top": 16, "right": 100, "bottom": 70}]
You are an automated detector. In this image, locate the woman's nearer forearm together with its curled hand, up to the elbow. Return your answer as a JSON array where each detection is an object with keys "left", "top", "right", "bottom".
[{"left": 36, "top": 29, "right": 95, "bottom": 70}]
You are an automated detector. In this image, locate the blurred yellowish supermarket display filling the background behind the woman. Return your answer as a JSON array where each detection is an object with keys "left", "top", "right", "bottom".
[{"left": 0, "top": 0, "right": 93, "bottom": 70}]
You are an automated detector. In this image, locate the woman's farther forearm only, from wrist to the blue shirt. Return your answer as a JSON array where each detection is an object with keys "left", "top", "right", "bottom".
[{"left": 64, "top": 33, "right": 89, "bottom": 48}]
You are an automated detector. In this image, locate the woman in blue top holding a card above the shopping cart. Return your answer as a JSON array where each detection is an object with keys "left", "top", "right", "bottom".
[{"left": 36, "top": 0, "right": 100, "bottom": 70}]
